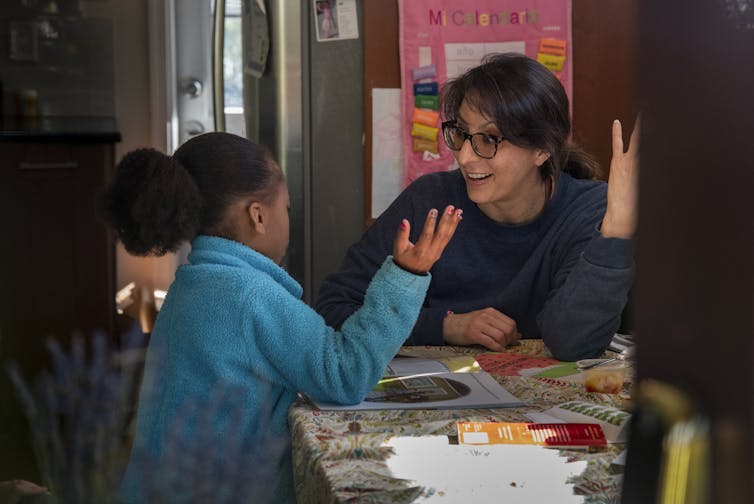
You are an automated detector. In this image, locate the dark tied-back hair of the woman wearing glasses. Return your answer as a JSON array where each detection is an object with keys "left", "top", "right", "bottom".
[{"left": 442, "top": 53, "right": 599, "bottom": 179}]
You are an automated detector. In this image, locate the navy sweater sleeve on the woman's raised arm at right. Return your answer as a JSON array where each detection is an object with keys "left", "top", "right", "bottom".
[{"left": 537, "top": 229, "right": 633, "bottom": 361}]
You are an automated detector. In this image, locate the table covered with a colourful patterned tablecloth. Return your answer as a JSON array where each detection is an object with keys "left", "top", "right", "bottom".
[{"left": 289, "top": 340, "right": 629, "bottom": 504}]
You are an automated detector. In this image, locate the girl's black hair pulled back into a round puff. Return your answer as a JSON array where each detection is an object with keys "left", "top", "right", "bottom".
[{"left": 100, "top": 133, "right": 285, "bottom": 256}]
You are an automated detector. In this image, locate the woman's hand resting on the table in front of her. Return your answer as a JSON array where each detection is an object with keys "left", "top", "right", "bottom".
[{"left": 443, "top": 307, "right": 521, "bottom": 352}]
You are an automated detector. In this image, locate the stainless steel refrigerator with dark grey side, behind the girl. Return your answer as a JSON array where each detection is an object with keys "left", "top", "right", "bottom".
[{"left": 244, "top": 0, "right": 364, "bottom": 302}]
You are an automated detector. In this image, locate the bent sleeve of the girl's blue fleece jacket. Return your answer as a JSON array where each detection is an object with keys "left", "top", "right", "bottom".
[{"left": 250, "top": 257, "right": 431, "bottom": 404}]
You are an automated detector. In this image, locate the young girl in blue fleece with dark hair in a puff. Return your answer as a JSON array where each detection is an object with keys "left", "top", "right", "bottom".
[{"left": 104, "top": 133, "right": 461, "bottom": 502}]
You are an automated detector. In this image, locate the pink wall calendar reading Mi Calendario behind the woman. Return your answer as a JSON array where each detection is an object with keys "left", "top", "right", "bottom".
[{"left": 398, "top": 0, "right": 573, "bottom": 187}]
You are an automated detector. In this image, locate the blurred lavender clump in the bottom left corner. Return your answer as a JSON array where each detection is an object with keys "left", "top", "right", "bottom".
[{"left": 8, "top": 331, "right": 143, "bottom": 504}]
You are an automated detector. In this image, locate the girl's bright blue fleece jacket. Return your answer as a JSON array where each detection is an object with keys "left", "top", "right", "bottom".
[{"left": 121, "top": 236, "right": 430, "bottom": 503}]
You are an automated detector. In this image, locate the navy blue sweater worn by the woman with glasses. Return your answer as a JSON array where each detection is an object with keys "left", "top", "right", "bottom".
[{"left": 315, "top": 170, "right": 633, "bottom": 361}]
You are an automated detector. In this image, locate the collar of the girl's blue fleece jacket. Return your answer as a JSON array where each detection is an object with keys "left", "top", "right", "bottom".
[{"left": 188, "top": 235, "right": 303, "bottom": 298}]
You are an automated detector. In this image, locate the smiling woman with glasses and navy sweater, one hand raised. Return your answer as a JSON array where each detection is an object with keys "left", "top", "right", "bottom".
[{"left": 315, "top": 54, "right": 638, "bottom": 360}]
